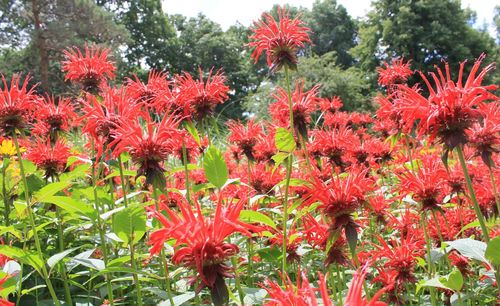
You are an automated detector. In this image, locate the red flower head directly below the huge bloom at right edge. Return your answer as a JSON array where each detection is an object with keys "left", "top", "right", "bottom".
[{"left": 398, "top": 157, "right": 447, "bottom": 210}]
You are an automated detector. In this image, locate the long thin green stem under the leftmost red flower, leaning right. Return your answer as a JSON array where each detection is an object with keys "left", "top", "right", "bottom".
[{"left": 12, "top": 131, "right": 61, "bottom": 306}]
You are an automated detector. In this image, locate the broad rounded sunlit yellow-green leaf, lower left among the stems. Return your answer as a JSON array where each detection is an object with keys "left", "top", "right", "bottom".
[{"left": 113, "top": 205, "right": 146, "bottom": 243}]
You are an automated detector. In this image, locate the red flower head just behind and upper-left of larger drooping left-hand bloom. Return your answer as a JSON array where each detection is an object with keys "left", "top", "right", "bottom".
[{"left": 82, "top": 88, "right": 142, "bottom": 145}]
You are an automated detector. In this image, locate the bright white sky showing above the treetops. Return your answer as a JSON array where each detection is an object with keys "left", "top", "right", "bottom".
[{"left": 162, "top": 0, "right": 500, "bottom": 36}]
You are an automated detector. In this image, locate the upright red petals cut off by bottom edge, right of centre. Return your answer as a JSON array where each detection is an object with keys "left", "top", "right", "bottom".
[{"left": 344, "top": 262, "right": 393, "bottom": 306}]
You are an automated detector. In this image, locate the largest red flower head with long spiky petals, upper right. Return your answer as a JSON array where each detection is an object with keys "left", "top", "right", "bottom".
[{"left": 394, "top": 55, "right": 498, "bottom": 153}]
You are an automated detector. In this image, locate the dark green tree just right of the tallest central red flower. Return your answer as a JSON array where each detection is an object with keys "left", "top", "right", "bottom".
[{"left": 305, "top": 0, "right": 357, "bottom": 67}]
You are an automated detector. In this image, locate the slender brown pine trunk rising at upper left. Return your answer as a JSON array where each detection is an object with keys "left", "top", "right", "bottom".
[{"left": 31, "top": 0, "right": 49, "bottom": 91}]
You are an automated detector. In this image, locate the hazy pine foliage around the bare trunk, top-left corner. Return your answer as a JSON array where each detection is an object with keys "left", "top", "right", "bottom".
[{"left": 0, "top": 0, "right": 128, "bottom": 93}]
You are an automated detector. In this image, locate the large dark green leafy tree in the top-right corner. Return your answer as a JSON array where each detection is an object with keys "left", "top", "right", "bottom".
[{"left": 353, "top": 0, "right": 495, "bottom": 72}]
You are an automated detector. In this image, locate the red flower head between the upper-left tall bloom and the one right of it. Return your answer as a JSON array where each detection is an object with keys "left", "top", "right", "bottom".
[{"left": 126, "top": 70, "right": 174, "bottom": 110}]
